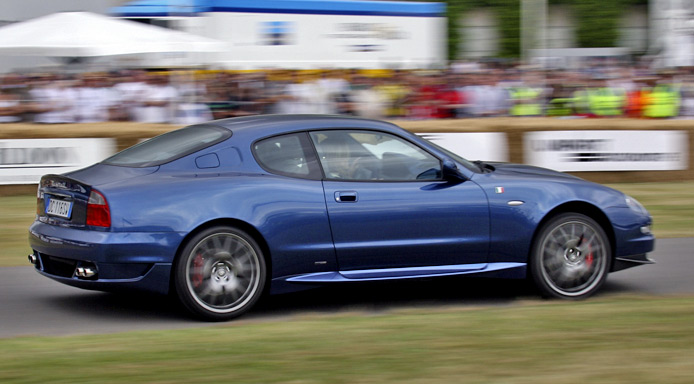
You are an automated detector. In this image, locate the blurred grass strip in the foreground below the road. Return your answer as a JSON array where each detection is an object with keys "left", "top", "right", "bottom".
[{"left": 0, "top": 297, "right": 694, "bottom": 384}]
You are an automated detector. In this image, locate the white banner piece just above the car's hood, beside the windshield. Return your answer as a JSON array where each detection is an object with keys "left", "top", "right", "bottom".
[{"left": 418, "top": 132, "right": 509, "bottom": 162}]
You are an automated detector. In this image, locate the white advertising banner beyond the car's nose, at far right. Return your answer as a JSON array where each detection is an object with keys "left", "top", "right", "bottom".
[{"left": 523, "top": 131, "right": 689, "bottom": 172}]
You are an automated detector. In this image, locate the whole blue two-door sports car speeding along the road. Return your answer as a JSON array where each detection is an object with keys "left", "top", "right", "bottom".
[{"left": 29, "top": 115, "right": 654, "bottom": 320}]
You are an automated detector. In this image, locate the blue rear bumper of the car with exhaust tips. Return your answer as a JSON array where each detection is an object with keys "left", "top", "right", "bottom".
[{"left": 29, "top": 222, "right": 183, "bottom": 294}]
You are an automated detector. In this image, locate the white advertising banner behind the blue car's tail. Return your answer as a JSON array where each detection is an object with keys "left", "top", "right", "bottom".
[{"left": 0, "top": 139, "right": 116, "bottom": 184}]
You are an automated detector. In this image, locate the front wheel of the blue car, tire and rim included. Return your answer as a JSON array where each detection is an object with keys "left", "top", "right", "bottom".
[{"left": 530, "top": 213, "right": 612, "bottom": 299}]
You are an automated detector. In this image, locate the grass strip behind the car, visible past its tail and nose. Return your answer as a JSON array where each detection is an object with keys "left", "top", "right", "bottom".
[{"left": 0, "top": 181, "right": 694, "bottom": 267}]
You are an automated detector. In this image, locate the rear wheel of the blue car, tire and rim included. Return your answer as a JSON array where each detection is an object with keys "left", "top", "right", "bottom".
[{"left": 173, "top": 226, "right": 267, "bottom": 321}]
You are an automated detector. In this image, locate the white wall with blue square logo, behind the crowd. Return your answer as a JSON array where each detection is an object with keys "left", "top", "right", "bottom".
[{"left": 207, "top": 11, "right": 446, "bottom": 69}]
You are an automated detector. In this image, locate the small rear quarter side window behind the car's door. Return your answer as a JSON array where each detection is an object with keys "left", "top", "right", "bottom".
[{"left": 253, "top": 133, "right": 321, "bottom": 179}]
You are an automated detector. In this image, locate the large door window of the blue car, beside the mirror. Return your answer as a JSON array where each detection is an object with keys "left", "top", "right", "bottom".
[{"left": 311, "top": 130, "right": 442, "bottom": 181}]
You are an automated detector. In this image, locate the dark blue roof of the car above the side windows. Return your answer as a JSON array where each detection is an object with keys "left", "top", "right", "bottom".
[{"left": 204, "top": 115, "right": 403, "bottom": 138}]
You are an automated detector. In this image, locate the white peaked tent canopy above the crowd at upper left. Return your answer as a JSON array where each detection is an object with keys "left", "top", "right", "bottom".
[{"left": 0, "top": 12, "right": 227, "bottom": 57}]
